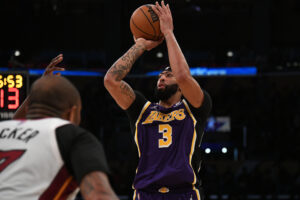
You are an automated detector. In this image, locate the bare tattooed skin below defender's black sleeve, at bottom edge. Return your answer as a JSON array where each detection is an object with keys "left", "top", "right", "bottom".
[{"left": 80, "top": 172, "right": 119, "bottom": 200}]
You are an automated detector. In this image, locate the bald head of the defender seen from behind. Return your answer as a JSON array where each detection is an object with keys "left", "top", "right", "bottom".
[{"left": 28, "top": 76, "right": 81, "bottom": 116}]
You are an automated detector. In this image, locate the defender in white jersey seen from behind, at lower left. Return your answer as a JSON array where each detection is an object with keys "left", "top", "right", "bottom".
[{"left": 0, "top": 66, "right": 118, "bottom": 200}]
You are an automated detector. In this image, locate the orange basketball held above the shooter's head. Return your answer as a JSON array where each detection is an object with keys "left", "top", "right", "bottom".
[{"left": 130, "top": 4, "right": 162, "bottom": 40}]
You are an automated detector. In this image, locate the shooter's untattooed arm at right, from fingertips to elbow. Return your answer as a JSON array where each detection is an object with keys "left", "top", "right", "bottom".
[{"left": 153, "top": 1, "right": 204, "bottom": 108}]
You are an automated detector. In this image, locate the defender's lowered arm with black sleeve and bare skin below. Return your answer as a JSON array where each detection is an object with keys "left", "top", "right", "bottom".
[{"left": 56, "top": 124, "right": 118, "bottom": 200}]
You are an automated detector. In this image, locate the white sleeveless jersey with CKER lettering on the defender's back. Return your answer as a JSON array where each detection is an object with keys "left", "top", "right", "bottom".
[{"left": 0, "top": 118, "right": 79, "bottom": 200}]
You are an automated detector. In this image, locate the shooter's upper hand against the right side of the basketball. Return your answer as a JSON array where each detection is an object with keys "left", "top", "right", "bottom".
[{"left": 152, "top": 1, "right": 174, "bottom": 37}]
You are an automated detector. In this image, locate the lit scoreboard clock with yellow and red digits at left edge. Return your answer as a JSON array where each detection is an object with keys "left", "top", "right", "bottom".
[{"left": 0, "top": 71, "right": 29, "bottom": 120}]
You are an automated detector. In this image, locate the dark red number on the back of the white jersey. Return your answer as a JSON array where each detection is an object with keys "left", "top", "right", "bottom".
[{"left": 0, "top": 150, "right": 25, "bottom": 173}]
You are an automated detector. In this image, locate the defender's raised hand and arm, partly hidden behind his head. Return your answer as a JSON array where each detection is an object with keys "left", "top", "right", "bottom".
[{"left": 13, "top": 54, "right": 65, "bottom": 119}]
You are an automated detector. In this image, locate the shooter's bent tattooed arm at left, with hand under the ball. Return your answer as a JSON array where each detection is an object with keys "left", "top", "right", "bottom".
[{"left": 104, "top": 38, "right": 163, "bottom": 110}]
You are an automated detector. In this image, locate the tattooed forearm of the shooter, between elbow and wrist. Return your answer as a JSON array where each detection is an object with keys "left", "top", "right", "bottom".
[{"left": 108, "top": 45, "right": 144, "bottom": 81}]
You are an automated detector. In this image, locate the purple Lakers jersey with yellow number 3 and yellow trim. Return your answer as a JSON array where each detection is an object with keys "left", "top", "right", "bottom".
[{"left": 133, "top": 100, "right": 197, "bottom": 193}]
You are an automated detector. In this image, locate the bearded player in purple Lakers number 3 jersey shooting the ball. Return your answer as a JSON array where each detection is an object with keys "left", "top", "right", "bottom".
[{"left": 104, "top": 1, "right": 211, "bottom": 200}]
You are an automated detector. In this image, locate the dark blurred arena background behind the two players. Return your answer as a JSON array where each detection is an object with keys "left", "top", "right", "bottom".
[{"left": 0, "top": 0, "right": 300, "bottom": 200}]
